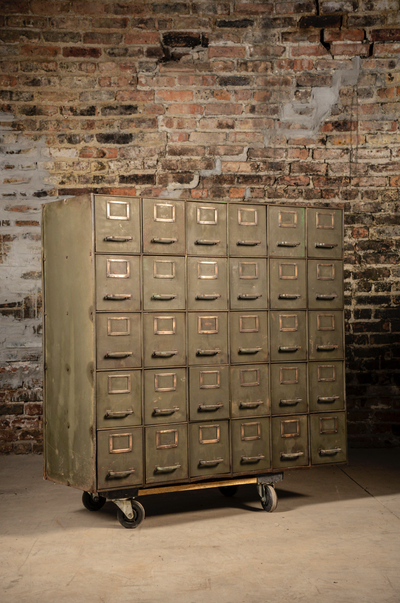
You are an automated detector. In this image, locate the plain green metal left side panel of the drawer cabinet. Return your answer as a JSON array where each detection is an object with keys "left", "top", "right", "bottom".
[{"left": 43, "top": 196, "right": 96, "bottom": 491}]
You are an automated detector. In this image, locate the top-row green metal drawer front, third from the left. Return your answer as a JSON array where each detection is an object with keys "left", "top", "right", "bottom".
[{"left": 186, "top": 203, "right": 227, "bottom": 257}]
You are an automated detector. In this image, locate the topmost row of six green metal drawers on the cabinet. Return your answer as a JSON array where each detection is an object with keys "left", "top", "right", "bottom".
[{"left": 95, "top": 196, "right": 343, "bottom": 258}]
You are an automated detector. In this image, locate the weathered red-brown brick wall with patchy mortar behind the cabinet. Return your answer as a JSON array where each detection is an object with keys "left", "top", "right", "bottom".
[{"left": 0, "top": 0, "right": 400, "bottom": 453}]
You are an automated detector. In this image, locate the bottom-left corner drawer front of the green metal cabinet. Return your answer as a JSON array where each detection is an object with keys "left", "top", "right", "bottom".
[{"left": 97, "top": 427, "right": 143, "bottom": 490}]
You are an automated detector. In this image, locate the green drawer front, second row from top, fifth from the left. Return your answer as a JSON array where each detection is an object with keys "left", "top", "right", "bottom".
[{"left": 269, "top": 259, "right": 307, "bottom": 310}]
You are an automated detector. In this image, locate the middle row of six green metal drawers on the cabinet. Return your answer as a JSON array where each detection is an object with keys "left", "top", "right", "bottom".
[{"left": 96, "top": 310, "right": 344, "bottom": 370}]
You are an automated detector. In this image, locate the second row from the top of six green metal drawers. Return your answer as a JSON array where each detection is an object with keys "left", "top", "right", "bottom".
[{"left": 96, "top": 255, "right": 343, "bottom": 312}]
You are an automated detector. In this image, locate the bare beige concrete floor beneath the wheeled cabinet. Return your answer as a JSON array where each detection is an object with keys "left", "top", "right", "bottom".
[{"left": 0, "top": 449, "right": 400, "bottom": 603}]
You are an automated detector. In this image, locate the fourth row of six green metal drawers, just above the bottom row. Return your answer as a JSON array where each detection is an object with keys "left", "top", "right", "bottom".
[{"left": 96, "top": 362, "right": 345, "bottom": 429}]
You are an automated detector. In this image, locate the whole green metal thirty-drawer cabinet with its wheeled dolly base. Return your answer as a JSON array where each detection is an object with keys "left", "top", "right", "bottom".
[{"left": 43, "top": 195, "right": 346, "bottom": 527}]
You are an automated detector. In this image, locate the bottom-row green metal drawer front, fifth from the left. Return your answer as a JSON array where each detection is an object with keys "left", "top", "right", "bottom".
[{"left": 272, "top": 415, "right": 309, "bottom": 469}]
